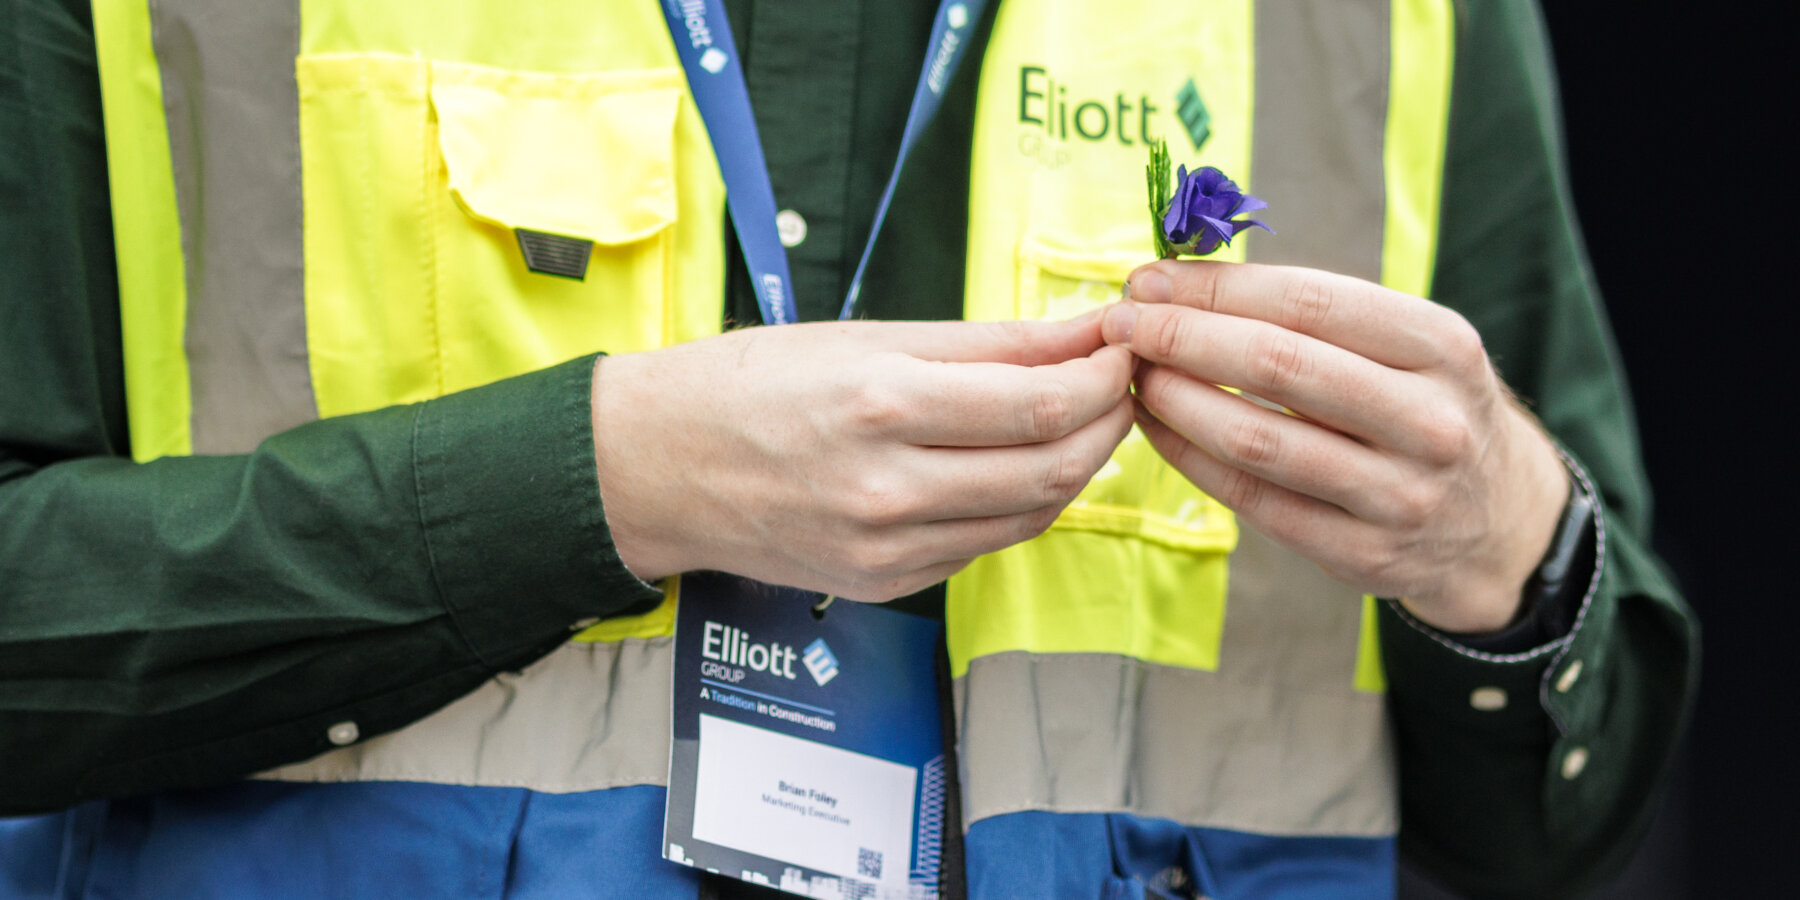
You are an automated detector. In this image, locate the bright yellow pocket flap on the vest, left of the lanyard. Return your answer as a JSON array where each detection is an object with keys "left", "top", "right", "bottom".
[{"left": 430, "top": 63, "right": 680, "bottom": 245}]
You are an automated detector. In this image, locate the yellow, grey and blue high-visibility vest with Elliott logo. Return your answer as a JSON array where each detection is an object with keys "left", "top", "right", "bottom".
[{"left": 95, "top": 0, "right": 1453, "bottom": 896}]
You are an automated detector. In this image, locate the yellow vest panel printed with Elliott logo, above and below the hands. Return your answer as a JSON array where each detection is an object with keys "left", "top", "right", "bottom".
[{"left": 945, "top": 0, "right": 1255, "bottom": 675}]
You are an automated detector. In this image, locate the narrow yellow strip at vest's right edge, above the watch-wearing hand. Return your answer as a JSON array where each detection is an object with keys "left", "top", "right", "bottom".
[{"left": 1381, "top": 0, "right": 1456, "bottom": 297}]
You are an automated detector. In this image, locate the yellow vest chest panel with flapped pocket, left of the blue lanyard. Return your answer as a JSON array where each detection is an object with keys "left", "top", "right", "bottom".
[{"left": 297, "top": 0, "right": 724, "bottom": 416}]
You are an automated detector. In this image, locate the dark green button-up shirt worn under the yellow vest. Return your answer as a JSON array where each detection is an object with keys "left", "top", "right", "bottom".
[{"left": 0, "top": 0, "right": 1697, "bottom": 896}]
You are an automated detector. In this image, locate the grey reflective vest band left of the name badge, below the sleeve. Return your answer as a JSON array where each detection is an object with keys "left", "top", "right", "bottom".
[{"left": 257, "top": 637, "right": 675, "bottom": 794}]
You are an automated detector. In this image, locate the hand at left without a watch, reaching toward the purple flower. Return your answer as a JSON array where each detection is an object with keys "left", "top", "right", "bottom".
[{"left": 594, "top": 317, "right": 1132, "bottom": 601}]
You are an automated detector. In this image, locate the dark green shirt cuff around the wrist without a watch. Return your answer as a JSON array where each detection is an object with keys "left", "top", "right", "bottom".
[{"left": 412, "top": 355, "right": 661, "bottom": 668}]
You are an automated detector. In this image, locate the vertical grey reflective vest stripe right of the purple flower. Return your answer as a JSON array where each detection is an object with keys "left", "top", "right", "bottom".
[{"left": 1247, "top": 0, "right": 1390, "bottom": 281}]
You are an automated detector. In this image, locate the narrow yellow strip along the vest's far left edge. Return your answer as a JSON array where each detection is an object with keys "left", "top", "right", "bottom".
[{"left": 94, "top": 0, "right": 193, "bottom": 463}]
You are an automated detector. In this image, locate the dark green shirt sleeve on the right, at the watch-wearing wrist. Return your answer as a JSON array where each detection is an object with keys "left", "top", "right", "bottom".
[{"left": 1381, "top": 0, "right": 1699, "bottom": 896}]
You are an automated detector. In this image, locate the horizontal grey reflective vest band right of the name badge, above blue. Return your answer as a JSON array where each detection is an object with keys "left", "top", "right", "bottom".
[{"left": 956, "top": 652, "right": 1399, "bottom": 837}]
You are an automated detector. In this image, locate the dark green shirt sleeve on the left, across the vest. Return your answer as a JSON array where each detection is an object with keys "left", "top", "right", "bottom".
[{"left": 0, "top": 0, "right": 655, "bottom": 815}]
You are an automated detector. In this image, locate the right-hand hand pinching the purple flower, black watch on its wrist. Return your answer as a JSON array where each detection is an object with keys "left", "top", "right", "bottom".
[{"left": 1103, "top": 261, "right": 1568, "bottom": 632}]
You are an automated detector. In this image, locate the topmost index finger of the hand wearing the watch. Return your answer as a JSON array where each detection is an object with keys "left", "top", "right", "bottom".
[{"left": 1129, "top": 261, "right": 1487, "bottom": 369}]
